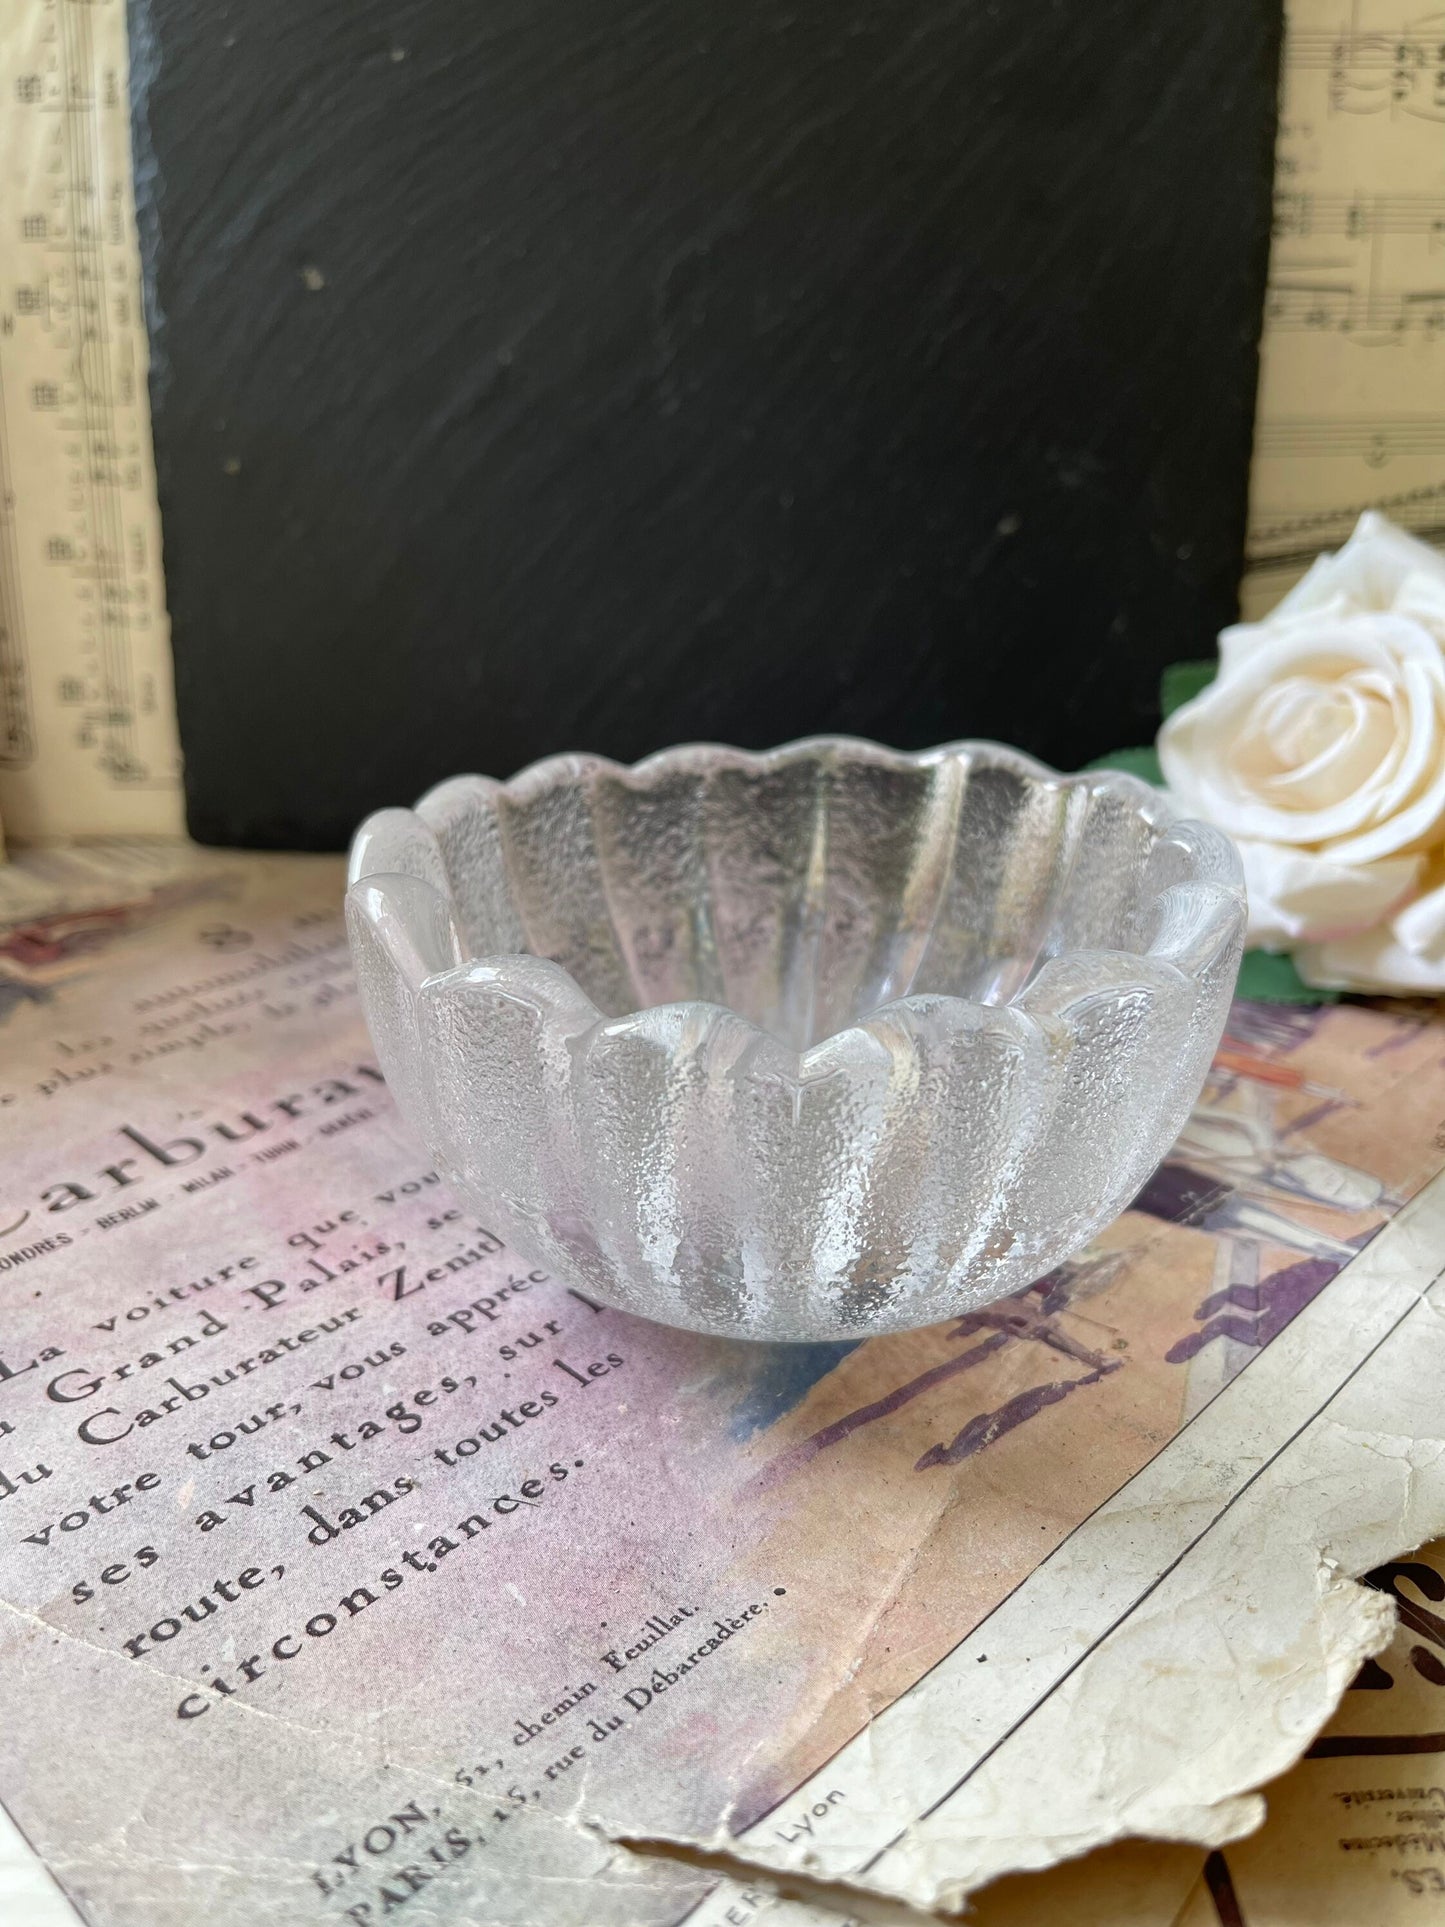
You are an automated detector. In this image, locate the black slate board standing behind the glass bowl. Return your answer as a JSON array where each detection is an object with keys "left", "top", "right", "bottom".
[{"left": 131, "top": 0, "right": 1279, "bottom": 848}]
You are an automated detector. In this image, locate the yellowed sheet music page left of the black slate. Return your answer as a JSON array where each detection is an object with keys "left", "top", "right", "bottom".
[{"left": 0, "top": 0, "right": 183, "bottom": 838}]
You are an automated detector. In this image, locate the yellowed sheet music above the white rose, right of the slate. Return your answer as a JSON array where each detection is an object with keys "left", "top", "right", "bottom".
[{"left": 1243, "top": 0, "right": 1445, "bottom": 619}]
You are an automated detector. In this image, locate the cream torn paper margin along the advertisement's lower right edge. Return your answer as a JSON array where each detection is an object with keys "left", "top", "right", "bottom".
[{"left": 647, "top": 1175, "right": 1445, "bottom": 1927}]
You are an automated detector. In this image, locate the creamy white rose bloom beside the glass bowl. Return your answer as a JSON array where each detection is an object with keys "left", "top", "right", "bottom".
[{"left": 1158, "top": 515, "right": 1445, "bottom": 990}]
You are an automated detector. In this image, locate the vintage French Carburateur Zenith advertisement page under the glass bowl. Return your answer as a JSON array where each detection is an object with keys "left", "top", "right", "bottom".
[{"left": 0, "top": 852, "right": 1445, "bottom": 1927}]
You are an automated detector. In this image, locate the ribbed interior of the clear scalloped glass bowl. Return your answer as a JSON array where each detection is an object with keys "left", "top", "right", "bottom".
[{"left": 418, "top": 742, "right": 1179, "bottom": 1050}]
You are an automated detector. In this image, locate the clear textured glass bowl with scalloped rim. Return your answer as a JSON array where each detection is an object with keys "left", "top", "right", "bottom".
[{"left": 347, "top": 738, "right": 1245, "bottom": 1339}]
